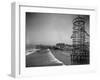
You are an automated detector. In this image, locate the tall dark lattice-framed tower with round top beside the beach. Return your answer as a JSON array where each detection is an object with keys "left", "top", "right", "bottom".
[{"left": 71, "top": 16, "right": 89, "bottom": 64}]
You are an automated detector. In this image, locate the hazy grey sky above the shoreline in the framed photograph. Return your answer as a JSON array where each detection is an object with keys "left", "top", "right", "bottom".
[{"left": 26, "top": 12, "right": 89, "bottom": 45}]
